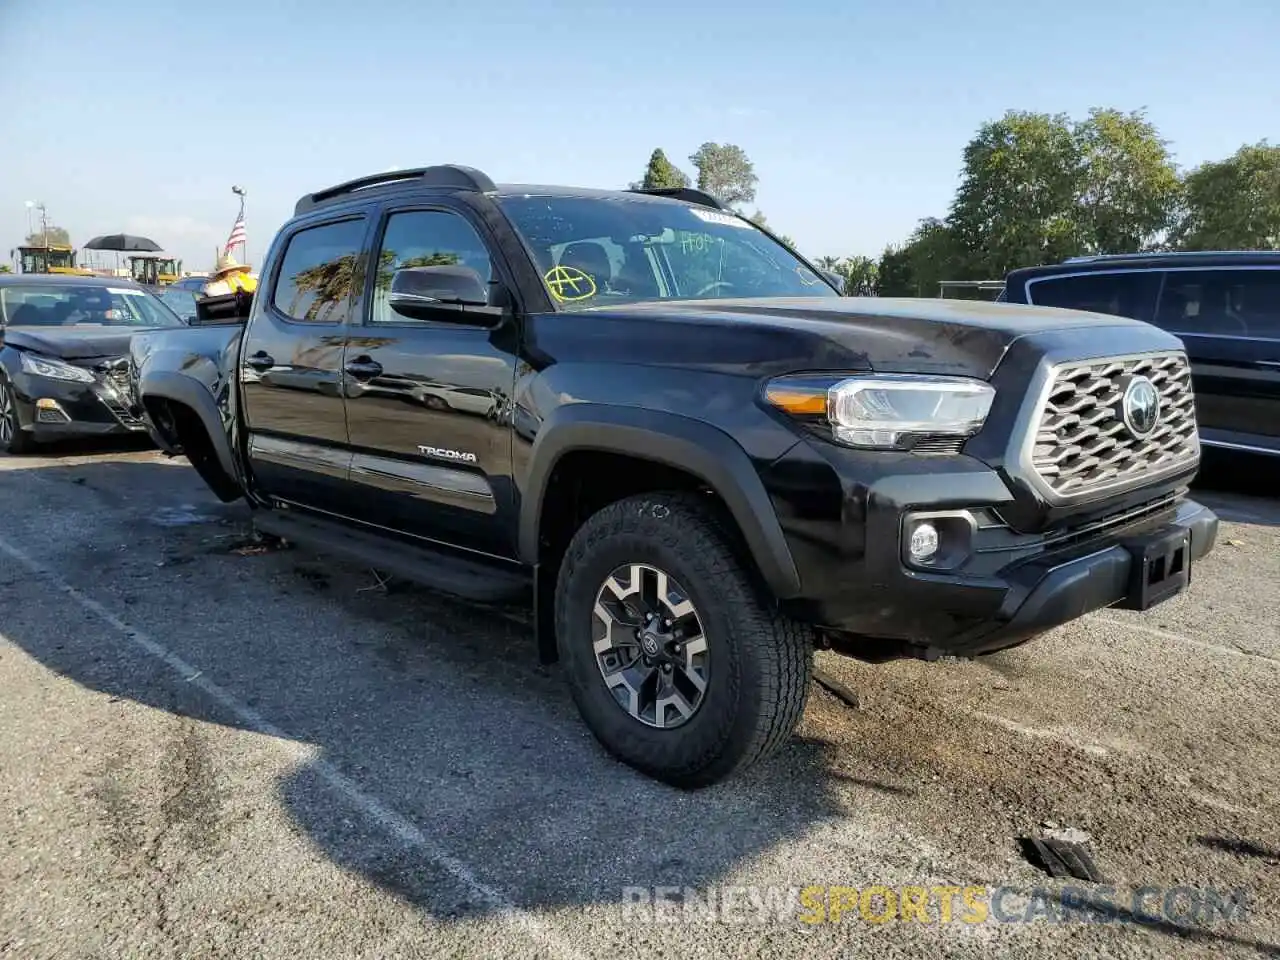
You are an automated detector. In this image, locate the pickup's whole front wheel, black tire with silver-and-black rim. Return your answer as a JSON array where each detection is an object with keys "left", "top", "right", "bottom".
[{"left": 556, "top": 493, "right": 813, "bottom": 787}]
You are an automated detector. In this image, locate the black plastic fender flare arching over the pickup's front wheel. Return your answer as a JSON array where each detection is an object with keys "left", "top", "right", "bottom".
[{"left": 520, "top": 403, "right": 800, "bottom": 599}]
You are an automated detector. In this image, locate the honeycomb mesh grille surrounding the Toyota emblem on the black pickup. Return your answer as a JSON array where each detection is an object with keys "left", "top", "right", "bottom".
[{"left": 1032, "top": 353, "right": 1199, "bottom": 497}]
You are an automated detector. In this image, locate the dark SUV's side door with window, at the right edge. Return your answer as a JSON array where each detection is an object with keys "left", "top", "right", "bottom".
[{"left": 1155, "top": 268, "right": 1280, "bottom": 453}]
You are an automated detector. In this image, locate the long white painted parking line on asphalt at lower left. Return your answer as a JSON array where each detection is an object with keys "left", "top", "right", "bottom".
[{"left": 0, "top": 539, "right": 582, "bottom": 960}]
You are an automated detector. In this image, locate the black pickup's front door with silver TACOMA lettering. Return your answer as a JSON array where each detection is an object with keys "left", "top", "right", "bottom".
[{"left": 344, "top": 206, "right": 517, "bottom": 558}]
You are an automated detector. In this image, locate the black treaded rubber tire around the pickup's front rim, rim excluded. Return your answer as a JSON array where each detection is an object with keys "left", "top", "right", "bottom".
[{"left": 556, "top": 492, "right": 814, "bottom": 788}]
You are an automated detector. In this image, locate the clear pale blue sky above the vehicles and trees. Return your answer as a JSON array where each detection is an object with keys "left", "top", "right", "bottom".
[{"left": 0, "top": 0, "right": 1280, "bottom": 269}]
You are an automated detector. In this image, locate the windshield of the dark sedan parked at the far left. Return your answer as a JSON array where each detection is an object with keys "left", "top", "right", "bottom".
[{"left": 0, "top": 283, "right": 182, "bottom": 326}]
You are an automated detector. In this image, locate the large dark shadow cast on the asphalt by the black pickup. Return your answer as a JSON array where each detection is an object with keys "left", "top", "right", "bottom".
[{"left": 0, "top": 462, "right": 1263, "bottom": 946}]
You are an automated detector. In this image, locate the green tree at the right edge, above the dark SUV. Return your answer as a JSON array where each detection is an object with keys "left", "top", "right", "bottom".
[{"left": 1175, "top": 141, "right": 1280, "bottom": 250}]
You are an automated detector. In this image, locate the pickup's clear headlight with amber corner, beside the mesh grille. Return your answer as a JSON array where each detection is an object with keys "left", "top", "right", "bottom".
[{"left": 764, "top": 374, "right": 996, "bottom": 449}]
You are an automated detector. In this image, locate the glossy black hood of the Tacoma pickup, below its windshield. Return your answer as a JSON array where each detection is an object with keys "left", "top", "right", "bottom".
[{"left": 556, "top": 297, "right": 1156, "bottom": 379}]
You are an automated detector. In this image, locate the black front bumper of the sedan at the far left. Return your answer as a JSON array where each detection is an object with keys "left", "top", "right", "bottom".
[{"left": 12, "top": 371, "right": 147, "bottom": 440}]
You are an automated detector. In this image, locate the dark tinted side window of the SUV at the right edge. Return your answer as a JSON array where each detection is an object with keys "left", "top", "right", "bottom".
[{"left": 1156, "top": 270, "right": 1280, "bottom": 339}]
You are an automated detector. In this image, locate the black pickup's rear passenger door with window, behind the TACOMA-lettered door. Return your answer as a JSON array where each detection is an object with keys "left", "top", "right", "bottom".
[{"left": 239, "top": 216, "right": 367, "bottom": 513}]
